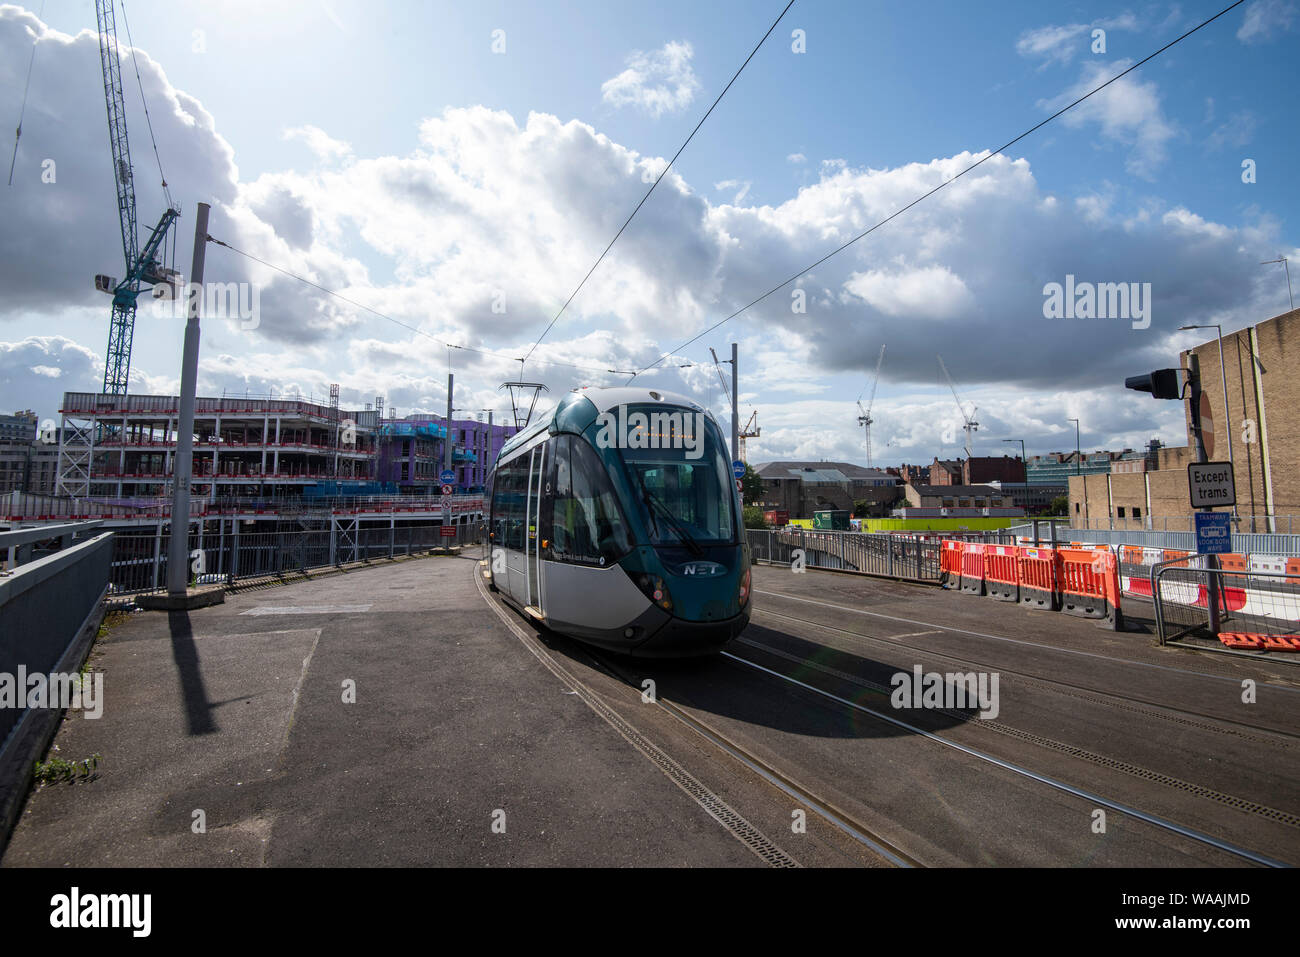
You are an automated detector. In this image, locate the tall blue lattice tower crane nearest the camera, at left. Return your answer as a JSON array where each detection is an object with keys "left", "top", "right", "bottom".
[{"left": 95, "top": 0, "right": 181, "bottom": 395}]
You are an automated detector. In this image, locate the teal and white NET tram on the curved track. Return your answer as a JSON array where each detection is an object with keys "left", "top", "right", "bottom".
[{"left": 489, "top": 387, "right": 750, "bottom": 657}]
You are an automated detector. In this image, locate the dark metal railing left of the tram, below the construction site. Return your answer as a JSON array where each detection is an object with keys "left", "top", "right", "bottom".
[{"left": 109, "top": 521, "right": 484, "bottom": 599}]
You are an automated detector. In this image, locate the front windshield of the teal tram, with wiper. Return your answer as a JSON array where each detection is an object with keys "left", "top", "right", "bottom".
[{"left": 620, "top": 407, "right": 736, "bottom": 553}]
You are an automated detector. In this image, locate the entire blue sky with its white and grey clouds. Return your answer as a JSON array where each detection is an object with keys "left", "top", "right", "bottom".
[{"left": 0, "top": 0, "right": 1300, "bottom": 463}]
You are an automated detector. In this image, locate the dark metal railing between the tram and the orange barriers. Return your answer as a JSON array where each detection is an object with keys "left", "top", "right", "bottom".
[{"left": 748, "top": 528, "right": 940, "bottom": 581}]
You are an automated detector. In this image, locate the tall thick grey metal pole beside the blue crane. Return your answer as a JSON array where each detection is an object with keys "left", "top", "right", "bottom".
[{"left": 166, "top": 203, "right": 209, "bottom": 596}]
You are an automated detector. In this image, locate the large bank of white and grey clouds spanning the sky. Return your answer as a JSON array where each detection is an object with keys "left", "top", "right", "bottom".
[{"left": 0, "top": 7, "right": 1284, "bottom": 462}]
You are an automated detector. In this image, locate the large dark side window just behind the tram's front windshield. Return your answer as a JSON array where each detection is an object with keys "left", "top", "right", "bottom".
[{"left": 551, "top": 436, "right": 632, "bottom": 566}]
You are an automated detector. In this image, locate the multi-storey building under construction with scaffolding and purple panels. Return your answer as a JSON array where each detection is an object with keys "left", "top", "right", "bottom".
[{"left": 57, "top": 393, "right": 514, "bottom": 502}]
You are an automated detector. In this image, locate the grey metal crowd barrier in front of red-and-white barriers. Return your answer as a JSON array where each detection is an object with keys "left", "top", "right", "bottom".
[{"left": 1151, "top": 555, "right": 1300, "bottom": 657}]
